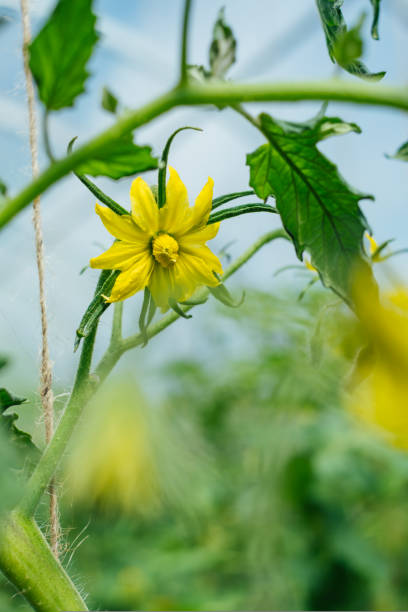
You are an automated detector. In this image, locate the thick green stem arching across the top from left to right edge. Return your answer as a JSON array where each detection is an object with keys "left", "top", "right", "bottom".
[{"left": 0, "top": 79, "right": 408, "bottom": 228}]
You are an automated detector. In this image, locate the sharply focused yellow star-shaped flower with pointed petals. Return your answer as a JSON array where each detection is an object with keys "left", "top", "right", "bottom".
[{"left": 90, "top": 168, "right": 222, "bottom": 312}]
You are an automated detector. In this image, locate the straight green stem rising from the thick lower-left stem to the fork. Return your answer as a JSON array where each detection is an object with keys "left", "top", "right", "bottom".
[{"left": 18, "top": 325, "right": 97, "bottom": 517}]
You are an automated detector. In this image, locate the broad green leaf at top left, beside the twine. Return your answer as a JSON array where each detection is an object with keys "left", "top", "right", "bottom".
[{"left": 30, "top": 0, "right": 98, "bottom": 110}]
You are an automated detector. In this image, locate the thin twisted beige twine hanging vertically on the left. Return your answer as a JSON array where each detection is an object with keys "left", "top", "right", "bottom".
[{"left": 20, "top": 0, "right": 60, "bottom": 558}]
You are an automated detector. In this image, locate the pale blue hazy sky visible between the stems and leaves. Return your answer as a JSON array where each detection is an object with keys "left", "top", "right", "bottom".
[{"left": 0, "top": 0, "right": 408, "bottom": 388}]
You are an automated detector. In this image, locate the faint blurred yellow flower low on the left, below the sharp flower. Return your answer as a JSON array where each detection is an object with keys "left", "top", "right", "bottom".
[{"left": 66, "top": 379, "right": 161, "bottom": 514}]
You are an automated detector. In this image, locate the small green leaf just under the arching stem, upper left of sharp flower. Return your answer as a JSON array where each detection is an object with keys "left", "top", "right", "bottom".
[{"left": 76, "top": 134, "right": 157, "bottom": 179}]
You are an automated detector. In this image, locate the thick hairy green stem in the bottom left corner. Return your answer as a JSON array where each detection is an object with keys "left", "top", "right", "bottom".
[{"left": 0, "top": 512, "right": 88, "bottom": 612}]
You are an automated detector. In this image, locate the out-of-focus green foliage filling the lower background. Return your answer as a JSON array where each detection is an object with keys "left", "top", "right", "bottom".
[{"left": 0, "top": 288, "right": 408, "bottom": 612}]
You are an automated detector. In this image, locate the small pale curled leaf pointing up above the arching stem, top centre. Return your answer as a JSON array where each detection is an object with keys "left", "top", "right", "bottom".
[{"left": 209, "top": 8, "right": 237, "bottom": 79}]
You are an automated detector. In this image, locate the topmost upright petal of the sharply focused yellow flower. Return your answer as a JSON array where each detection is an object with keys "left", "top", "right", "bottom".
[{"left": 160, "top": 166, "right": 190, "bottom": 236}]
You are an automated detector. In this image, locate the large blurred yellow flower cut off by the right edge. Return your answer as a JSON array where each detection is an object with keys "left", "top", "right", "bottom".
[{"left": 348, "top": 279, "right": 408, "bottom": 450}]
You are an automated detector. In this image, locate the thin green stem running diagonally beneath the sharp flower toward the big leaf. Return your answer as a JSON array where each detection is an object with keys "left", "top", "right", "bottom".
[{"left": 95, "top": 229, "right": 289, "bottom": 382}]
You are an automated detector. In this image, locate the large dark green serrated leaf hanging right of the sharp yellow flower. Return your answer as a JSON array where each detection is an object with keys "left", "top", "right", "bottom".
[{"left": 247, "top": 114, "right": 371, "bottom": 301}]
